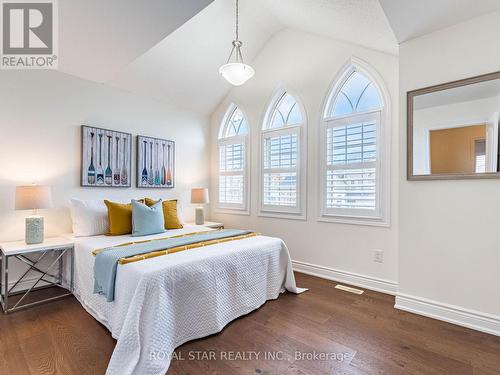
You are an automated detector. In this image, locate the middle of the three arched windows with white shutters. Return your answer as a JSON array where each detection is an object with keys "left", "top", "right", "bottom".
[{"left": 260, "top": 90, "right": 306, "bottom": 218}]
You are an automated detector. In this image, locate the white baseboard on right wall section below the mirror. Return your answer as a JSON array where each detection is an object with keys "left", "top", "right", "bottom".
[{"left": 394, "top": 294, "right": 500, "bottom": 336}]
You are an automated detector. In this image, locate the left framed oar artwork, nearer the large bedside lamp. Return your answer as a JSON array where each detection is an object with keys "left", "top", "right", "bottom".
[{"left": 81, "top": 125, "right": 132, "bottom": 188}]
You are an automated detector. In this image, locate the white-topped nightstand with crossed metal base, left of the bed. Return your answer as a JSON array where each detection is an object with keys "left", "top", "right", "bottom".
[{"left": 0, "top": 237, "right": 74, "bottom": 314}]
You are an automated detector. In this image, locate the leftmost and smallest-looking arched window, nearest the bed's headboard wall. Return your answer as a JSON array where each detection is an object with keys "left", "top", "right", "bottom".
[{"left": 217, "top": 104, "right": 249, "bottom": 211}]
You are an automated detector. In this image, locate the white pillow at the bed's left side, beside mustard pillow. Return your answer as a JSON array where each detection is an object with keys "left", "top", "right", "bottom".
[{"left": 71, "top": 199, "right": 109, "bottom": 237}]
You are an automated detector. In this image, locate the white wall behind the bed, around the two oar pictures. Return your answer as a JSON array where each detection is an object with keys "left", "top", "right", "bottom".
[{"left": 0, "top": 71, "right": 209, "bottom": 241}]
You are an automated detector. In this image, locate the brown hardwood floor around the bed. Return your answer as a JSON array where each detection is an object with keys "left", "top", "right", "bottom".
[{"left": 0, "top": 274, "right": 500, "bottom": 375}]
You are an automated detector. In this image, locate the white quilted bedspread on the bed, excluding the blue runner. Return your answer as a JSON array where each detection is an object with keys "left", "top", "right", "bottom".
[{"left": 64, "top": 225, "right": 305, "bottom": 375}]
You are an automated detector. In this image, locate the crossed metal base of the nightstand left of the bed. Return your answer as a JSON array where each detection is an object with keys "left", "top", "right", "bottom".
[{"left": 0, "top": 247, "right": 74, "bottom": 314}]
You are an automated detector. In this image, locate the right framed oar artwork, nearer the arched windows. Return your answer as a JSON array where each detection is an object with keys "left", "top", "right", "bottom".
[{"left": 137, "top": 135, "right": 175, "bottom": 188}]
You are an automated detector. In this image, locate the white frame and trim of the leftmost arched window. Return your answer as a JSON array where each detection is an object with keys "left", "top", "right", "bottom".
[{"left": 214, "top": 103, "right": 251, "bottom": 216}]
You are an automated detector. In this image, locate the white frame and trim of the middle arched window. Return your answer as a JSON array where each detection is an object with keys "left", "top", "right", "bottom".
[{"left": 257, "top": 88, "right": 307, "bottom": 220}]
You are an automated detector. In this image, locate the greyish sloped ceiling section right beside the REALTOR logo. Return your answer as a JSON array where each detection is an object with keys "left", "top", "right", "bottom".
[{"left": 58, "top": 0, "right": 213, "bottom": 82}]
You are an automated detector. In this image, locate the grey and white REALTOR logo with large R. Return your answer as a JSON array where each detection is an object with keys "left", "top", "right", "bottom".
[{"left": 0, "top": 0, "right": 58, "bottom": 69}]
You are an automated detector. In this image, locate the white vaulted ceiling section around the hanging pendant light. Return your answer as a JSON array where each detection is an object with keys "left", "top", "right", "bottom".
[{"left": 109, "top": 0, "right": 397, "bottom": 113}]
